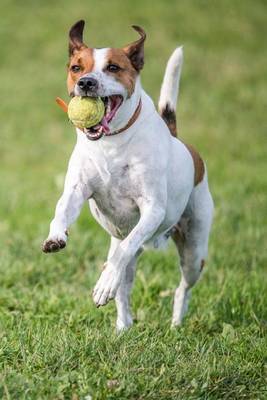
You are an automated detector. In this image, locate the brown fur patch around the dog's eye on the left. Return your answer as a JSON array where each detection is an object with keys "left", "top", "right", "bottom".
[{"left": 67, "top": 46, "right": 94, "bottom": 94}]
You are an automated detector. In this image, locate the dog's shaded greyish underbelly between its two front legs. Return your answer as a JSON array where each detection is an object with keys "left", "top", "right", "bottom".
[{"left": 89, "top": 192, "right": 140, "bottom": 239}]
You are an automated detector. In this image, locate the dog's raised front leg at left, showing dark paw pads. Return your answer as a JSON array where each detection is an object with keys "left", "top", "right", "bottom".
[{"left": 42, "top": 166, "right": 91, "bottom": 253}]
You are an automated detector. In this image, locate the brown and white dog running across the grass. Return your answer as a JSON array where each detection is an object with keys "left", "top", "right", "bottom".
[{"left": 42, "top": 20, "right": 214, "bottom": 331}]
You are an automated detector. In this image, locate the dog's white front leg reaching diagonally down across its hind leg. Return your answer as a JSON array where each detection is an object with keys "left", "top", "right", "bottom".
[{"left": 93, "top": 203, "right": 165, "bottom": 307}]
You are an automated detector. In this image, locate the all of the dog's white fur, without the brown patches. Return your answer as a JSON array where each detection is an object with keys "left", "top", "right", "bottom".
[{"left": 46, "top": 48, "right": 216, "bottom": 330}]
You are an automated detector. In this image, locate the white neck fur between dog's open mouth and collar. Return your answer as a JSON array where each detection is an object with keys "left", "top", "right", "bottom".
[{"left": 110, "top": 77, "right": 142, "bottom": 132}]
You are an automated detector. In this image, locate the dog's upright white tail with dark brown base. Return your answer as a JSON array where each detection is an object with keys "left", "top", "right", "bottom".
[{"left": 158, "top": 47, "right": 183, "bottom": 136}]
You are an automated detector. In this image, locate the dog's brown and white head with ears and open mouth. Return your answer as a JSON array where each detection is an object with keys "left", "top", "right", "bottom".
[{"left": 67, "top": 21, "right": 146, "bottom": 138}]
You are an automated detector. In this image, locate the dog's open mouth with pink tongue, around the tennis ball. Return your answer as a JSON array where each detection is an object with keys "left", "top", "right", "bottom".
[{"left": 84, "top": 94, "right": 123, "bottom": 140}]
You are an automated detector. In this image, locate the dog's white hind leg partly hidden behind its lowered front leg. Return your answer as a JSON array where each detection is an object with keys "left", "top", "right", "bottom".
[{"left": 108, "top": 237, "right": 140, "bottom": 332}]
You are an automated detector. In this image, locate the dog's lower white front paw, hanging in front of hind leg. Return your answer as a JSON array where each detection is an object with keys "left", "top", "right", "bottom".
[{"left": 93, "top": 264, "right": 121, "bottom": 307}]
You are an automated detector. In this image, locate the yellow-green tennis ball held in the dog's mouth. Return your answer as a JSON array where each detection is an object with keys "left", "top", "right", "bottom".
[{"left": 68, "top": 96, "right": 105, "bottom": 128}]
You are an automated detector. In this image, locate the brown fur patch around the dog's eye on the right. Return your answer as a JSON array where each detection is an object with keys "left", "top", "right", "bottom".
[{"left": 105, "top": 49, "right": 138, "bottom": 97}]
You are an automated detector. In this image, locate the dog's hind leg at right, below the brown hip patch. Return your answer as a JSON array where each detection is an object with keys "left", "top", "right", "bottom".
[{"left": 172, "top": 173, "right": 213, "bottom": 326}]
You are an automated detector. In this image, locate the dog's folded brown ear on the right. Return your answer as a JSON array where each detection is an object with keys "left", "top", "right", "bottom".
[{"left": 123, "top": 25, "right": 146, "bottom": 72}]
